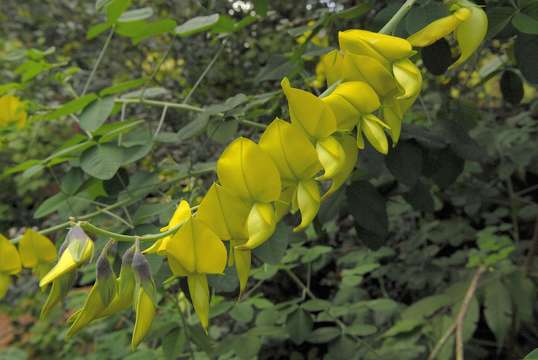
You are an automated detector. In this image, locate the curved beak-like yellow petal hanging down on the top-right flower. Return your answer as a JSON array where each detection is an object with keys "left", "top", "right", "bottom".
[{"left": 449, "top": 0, "right": 488, "bottom": 69}]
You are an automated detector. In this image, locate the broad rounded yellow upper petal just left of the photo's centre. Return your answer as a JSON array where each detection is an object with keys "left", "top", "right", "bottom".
[{"left": 217, "top": 137, "right": 281, "bottom": 202}]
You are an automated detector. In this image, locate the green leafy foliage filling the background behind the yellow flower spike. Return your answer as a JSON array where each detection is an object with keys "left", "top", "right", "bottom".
[{"left": 0, "top": 0, "right": 538, "bottom": 360}]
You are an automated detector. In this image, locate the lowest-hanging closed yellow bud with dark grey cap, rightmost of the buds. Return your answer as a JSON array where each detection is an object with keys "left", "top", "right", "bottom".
[{"left": 131, "top": 251, "right": 157, "bottom": 350}]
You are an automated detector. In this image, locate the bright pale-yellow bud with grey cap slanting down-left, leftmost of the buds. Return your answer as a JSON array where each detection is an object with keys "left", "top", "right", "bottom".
[{"left": 39, "top": 225, "right": 94, "bottom": 288}]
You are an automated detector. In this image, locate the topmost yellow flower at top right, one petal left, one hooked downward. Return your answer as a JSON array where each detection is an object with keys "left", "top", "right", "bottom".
[{"left": 407, "top": 0, "right": 488, "bottom": 69}]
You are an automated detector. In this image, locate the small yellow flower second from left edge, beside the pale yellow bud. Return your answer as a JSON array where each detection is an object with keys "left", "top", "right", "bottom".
[{"left": 19, "top": 229, "right": 56, "bottom": 279}]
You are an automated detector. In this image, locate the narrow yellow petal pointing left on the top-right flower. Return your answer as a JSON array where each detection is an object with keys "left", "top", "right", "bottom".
[{"left": 407, "top": 8, "right": 471, "bottom": 47}]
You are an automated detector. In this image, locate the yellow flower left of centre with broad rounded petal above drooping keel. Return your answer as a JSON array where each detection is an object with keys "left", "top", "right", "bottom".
[{"left": 217, "top": 137, "right": 282, "bottom": 250}]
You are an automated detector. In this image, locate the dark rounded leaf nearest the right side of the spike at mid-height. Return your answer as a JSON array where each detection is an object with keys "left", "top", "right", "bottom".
[{"left": 385, "top": 141, "right": 422, "bottom": 186}]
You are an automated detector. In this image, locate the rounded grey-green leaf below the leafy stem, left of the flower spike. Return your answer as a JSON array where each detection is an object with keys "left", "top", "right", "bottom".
[{"left": 80, "top": 144, "right": 123, "bottom": 180}]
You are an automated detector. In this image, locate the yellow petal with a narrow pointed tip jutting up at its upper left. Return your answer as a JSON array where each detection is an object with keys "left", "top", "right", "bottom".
[{"left": 281, "top": 78, "right": 336, "bottom": 139}]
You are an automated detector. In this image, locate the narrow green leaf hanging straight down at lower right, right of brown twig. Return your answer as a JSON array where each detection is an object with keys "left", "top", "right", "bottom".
[{"left": 484, "top": 279, "right": 512, "bottom": 346}]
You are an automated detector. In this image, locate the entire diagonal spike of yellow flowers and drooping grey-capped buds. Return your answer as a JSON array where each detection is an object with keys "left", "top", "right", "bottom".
[{"left": 27, "top": 9, "right": 487, "bottom": 348}]
